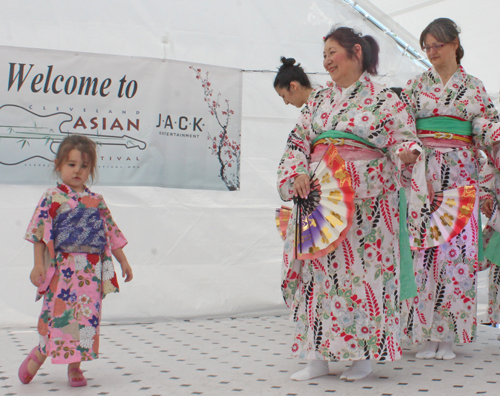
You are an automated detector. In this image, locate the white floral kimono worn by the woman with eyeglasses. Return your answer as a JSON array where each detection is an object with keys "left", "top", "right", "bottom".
[{"left": 402, "top": 66, "right": 500, "bottom": 343}]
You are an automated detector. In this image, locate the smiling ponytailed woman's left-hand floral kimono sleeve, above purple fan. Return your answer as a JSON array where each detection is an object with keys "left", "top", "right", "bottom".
[{"left": 278, "top": 104, "right": 312, "bottom": 201}]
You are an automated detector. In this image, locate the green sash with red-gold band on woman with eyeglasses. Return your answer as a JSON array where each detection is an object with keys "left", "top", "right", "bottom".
[{"left": 417, "top": 116, "right": 472, "bottom": 143}]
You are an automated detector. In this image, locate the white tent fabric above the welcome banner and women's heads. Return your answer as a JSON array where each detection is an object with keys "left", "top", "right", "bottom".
[{"left": 0, "top": 0, "right": 500, "bottom": 99}]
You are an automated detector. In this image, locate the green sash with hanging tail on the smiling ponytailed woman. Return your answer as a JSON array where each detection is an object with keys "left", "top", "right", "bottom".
[{"left": 313, "top": 130, "right": 417, "bottom": 300}]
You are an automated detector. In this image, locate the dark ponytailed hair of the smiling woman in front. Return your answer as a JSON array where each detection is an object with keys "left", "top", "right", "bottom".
[{"left": 323, "top": 26, "right": 380, "bottom": 75}]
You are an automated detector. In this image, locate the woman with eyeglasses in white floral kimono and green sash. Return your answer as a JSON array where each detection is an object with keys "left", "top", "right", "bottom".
[{"left": 402, "top": 18, "right": 500, "bottom": 359}]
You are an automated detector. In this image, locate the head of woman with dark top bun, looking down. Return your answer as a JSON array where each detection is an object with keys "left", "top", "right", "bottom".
[{"left": 274, "top": 56, "right": 313, "bottom": 108}]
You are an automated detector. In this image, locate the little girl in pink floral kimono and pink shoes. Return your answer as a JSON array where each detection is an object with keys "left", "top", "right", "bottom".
[{"left": 19, "top": 135, "right": 133, "bottom": 387}]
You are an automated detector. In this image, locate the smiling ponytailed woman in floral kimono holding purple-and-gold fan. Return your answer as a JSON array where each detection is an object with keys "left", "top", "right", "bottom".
[{"left": 278, "top": 27, "right": 426, "bottom": 380}]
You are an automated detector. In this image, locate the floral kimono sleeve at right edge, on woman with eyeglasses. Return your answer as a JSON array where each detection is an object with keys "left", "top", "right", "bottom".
[{"left": 472, "top": 79, "right": 500, "bottom": 147}]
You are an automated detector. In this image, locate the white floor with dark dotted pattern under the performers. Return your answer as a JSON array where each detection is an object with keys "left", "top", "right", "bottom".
[{"left": 0, "top": 317, "right": 500, "bottom": 396}]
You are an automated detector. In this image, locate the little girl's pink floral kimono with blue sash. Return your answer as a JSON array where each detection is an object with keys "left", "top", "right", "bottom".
[{"left": 25, "top": 184, "right": 127, "bottom": 364}]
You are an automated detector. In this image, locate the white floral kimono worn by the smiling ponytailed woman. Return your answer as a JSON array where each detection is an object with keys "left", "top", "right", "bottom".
[{"left": 278, "top": 74, "right": 425, "bottom": 361}]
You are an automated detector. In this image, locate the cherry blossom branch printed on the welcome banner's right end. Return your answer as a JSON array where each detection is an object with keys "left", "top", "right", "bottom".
[{"left": 189, "top": 66, "right": 241, "bottom": 191}]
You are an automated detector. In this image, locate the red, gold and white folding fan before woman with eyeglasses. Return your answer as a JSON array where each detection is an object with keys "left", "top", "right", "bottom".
[{"left": 425, "top": 186, "right": 476, "bottom": 249}]
